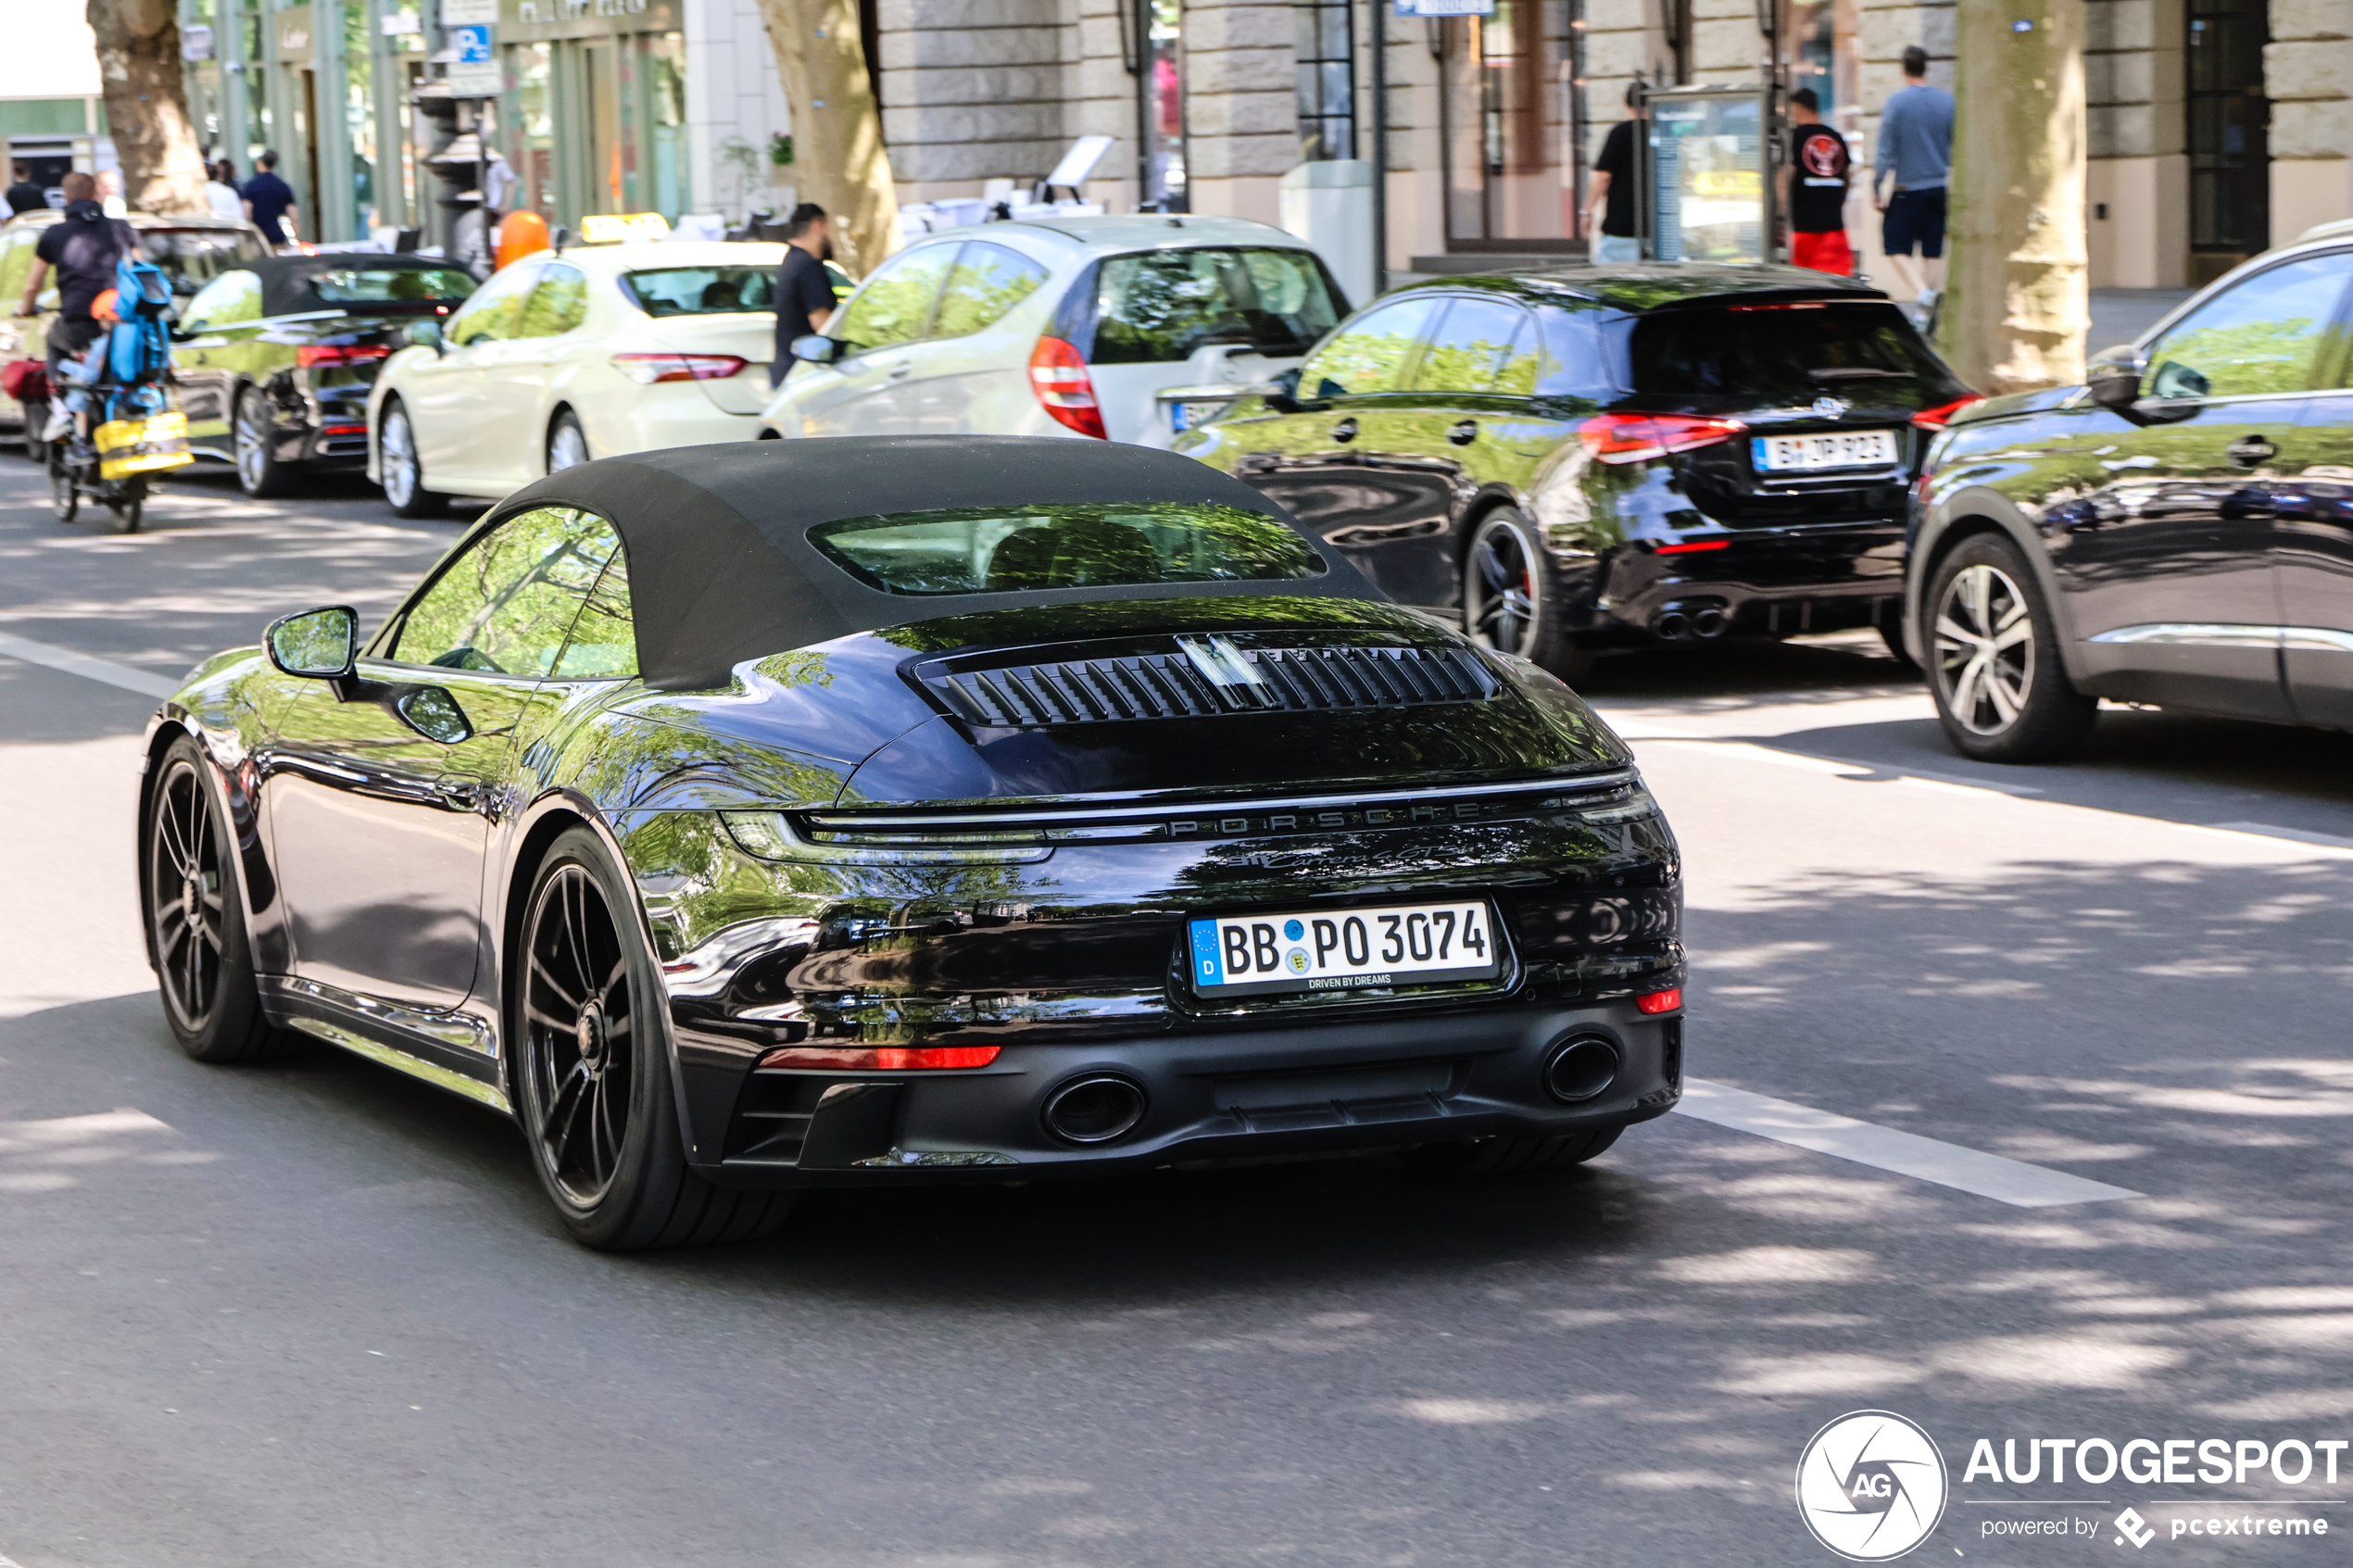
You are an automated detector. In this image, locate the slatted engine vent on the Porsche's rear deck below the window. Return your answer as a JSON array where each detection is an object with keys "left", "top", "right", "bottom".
[{"left": 915, "top": 637, "right": 1496, "bottom": 729}]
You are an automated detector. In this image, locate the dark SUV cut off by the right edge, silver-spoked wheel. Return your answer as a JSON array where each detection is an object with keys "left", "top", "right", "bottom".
[{"left": 1906, "top": 235, "right": 2353, "bottom": 761}]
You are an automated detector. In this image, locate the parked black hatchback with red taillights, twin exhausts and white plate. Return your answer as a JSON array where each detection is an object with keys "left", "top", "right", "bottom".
[{"left": 1176, "top": 266, "right": 1972, "bottom": 677}]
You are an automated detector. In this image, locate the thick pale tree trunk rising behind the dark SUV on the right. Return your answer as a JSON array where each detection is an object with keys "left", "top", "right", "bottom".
[{"left": 1939, "top": 0, "right": 2090, "bottom": 395}]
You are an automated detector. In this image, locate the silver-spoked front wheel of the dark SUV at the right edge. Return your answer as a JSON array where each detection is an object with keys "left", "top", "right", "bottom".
[{"left": 1927, "top": 533, "right": 2099, "bottom": 761}]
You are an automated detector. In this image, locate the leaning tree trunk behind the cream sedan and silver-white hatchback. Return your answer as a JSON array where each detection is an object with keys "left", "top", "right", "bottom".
[{"left": 760, "top": 0, "right": 899, "bottom": 278}]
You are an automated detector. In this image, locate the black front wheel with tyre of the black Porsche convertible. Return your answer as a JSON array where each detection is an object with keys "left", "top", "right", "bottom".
[{"left": 141, "top": 735, "right": 292, "bottom": 1062}]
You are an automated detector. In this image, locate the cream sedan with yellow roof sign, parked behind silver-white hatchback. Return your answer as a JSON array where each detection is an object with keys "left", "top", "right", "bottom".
[{"left": 367, "top": 240, "right": 784, "bottom": 517}]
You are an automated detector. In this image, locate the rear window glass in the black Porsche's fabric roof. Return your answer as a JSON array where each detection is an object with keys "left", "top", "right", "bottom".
[{"left": 810, "top": 503, "right": 1325, "bottom": 595}]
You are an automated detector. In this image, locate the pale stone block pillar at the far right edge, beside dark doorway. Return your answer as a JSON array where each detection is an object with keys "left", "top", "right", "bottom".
[{"left": 2263, "top": 0, "right": 2353, "bottom": 245}]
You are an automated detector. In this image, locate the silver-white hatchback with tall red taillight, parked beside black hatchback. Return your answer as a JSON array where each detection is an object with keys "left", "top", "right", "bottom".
[{"left": 760, "top": 214, "right": 1348, "bottom": 446}]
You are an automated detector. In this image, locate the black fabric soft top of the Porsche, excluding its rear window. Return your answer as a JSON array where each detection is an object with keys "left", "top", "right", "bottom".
[{"left": 486, "top": 435, "right": 1386, "bottom": 691}]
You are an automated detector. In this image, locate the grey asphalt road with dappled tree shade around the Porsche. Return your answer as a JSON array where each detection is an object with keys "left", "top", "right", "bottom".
[{"left": 0, "top": 458, "right": 2353, "bottom": 1568}]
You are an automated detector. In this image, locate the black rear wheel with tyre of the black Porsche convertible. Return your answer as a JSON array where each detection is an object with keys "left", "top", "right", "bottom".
[{"left": 510, "top": 827, "right": 790, "bottom": 1250}]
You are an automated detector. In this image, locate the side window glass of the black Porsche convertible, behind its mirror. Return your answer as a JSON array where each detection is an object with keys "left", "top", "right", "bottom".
[{"left": 393, "top": 506, "right": 622, "bottom": 677}]
